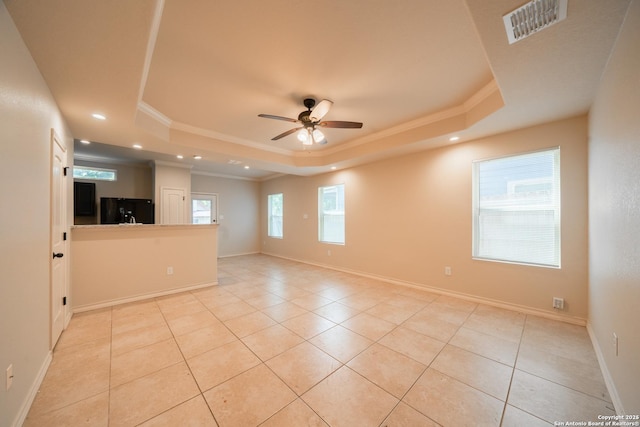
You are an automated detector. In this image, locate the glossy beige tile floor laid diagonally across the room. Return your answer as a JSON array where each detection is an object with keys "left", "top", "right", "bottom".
[{"left": 25, "top": 255, "right": 614, "bottom": 427}]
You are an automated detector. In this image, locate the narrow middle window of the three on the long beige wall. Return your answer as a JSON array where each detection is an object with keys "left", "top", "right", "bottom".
[{"left": 318, "top": 184, "right": 344, "bottom": 244}]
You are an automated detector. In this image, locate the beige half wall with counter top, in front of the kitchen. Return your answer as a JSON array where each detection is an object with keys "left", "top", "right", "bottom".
[{"left": 70, "top": 224, "right": 218, "bottom": 312}]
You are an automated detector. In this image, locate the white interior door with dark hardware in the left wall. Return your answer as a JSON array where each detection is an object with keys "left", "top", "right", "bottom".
[{"left": 50, "top": 130, "right": 68, "bottom": 348}]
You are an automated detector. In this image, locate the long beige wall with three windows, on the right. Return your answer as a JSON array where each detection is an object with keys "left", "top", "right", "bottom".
[{"left": 260, "top": 116, "right": 587, "bottom": 322}]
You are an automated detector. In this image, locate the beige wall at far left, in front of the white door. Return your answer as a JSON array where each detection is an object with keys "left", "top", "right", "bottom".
[{"left": 0, "top": 1, "right": 73, "bottom": 426}]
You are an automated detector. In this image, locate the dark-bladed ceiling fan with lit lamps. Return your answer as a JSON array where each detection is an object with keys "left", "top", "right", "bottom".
[{"left": 258, "top": 98, "right": 362, "bottom": 145}]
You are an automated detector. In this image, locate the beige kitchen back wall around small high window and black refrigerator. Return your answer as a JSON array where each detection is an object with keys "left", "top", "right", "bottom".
[{"left": 74, "top": 159, "right": 154, "bottom": 224}]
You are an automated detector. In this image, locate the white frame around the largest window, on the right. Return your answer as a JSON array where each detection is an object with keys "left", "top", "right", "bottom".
[{"left": 471, "top": 146, "right": 562, "bottom": 269}]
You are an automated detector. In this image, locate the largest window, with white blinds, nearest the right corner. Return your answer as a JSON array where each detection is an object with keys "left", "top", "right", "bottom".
[{"left": 473, "top": 148, "right": 560, "bottom": 267}]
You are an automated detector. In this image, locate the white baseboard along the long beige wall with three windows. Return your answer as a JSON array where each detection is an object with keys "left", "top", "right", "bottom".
[{"left": 262, "top": 252, "right": 587, "bottom": 326}]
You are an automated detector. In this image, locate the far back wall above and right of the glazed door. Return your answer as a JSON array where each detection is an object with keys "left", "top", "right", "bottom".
[{"left": 191, "top": 173, "right": 260, "bottom": 256}]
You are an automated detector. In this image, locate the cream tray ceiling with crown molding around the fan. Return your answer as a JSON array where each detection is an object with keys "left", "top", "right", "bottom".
[{"left": 4, "top": 0, "right": 630, "bottom": 179}]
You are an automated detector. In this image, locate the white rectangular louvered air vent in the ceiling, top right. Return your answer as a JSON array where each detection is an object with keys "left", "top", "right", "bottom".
[{"left": 502, "top": 0, "right": 567, "bottom": 44}]
